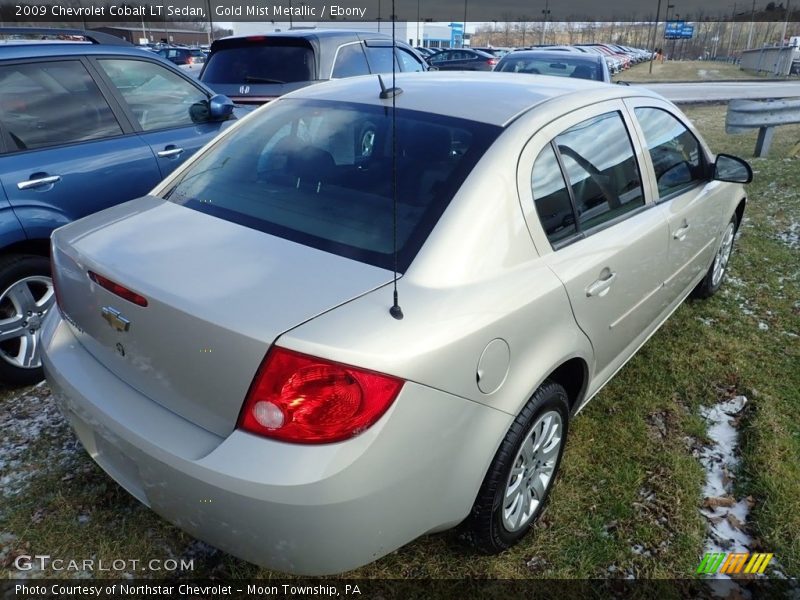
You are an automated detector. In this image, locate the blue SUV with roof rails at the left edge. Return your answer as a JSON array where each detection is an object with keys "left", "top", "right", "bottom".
[{"left": 0, "top": 28, "right": 233, "bottom": 384}]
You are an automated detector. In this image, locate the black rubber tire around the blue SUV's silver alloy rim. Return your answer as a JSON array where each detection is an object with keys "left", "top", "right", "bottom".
[{"left": 0, "top": 254, "right": 51, "bottom": 385}]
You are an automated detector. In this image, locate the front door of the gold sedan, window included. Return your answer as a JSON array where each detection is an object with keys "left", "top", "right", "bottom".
[{"left": 626, "top": 98, "right": 728, "bottom": 299}]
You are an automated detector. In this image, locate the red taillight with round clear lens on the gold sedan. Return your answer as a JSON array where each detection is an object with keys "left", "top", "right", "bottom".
[{"left": 238, "top": 347, "right": 403, "bottom": 444}]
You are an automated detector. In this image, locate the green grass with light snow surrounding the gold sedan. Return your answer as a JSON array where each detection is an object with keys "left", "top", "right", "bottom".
[{"left": 0, "top": 107, "right": 800, "bottom": 578}]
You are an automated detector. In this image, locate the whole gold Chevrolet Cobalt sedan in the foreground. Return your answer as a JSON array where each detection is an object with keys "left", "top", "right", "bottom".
[{"left": 42, "top": 73, "right": 752, "bottom": 574}]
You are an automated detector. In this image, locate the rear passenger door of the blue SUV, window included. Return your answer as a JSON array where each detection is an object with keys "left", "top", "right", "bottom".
[{"left": 0, "top": 58, "right": 161, "bottom": 238}]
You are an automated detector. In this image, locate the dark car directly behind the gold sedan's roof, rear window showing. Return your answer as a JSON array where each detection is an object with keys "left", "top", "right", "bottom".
[{"left": 494, "top": 50, "right": 611, "bottom": 82}]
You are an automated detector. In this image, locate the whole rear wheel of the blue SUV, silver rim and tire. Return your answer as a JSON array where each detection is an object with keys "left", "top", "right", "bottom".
[{"left": 0, "top": 254, "right": 55, "bottom": 385}]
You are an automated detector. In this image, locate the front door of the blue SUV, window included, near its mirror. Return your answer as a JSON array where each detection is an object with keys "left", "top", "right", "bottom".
[{"left": 94, "top": 57, "right": 228, "bottom": 178}]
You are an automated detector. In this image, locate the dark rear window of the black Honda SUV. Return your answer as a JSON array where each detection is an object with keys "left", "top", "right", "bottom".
[{"left": 202, "top": 44, "right": 316, "bottom": 84}]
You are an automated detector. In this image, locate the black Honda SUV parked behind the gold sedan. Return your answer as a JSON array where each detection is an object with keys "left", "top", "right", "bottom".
[{"left": 200, "top": 29, "right": 428, "bottom": 104}]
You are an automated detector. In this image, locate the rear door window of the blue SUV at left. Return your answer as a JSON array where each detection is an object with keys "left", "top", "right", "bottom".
[{"left": 0, "top": 61, "right": 122, "bottom": 152}]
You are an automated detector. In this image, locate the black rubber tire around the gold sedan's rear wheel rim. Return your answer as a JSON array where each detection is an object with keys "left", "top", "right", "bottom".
[{"left": 464, "top": 380, "right": 569, "bottom": 554}]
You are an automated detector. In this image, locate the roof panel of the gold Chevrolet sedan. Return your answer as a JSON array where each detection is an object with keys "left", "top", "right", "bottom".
[{"left": 284, "top": 71, "right": 661, "bottom": 127}]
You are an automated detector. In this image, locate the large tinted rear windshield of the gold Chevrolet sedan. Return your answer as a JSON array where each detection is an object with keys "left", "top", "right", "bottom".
[{"left": 164, "top": 99, "right": 501, "bottom": 272}]
